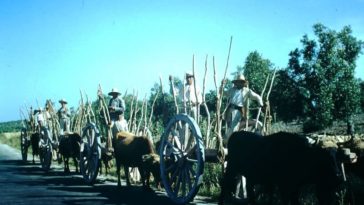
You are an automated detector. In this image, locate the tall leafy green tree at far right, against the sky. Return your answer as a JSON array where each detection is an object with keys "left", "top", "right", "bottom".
[{"left": 286, "top": 24, "right": 364, "bottom": 130}]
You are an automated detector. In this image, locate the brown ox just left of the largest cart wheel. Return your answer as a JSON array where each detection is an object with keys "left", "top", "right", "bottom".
[{"left": 113, "top": 132, "right": 159, "bottom": 188}]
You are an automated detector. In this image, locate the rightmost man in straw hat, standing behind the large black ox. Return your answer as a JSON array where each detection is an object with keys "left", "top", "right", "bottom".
[{"left": 225, "top": 74, "right": 263, "bottom": 141}]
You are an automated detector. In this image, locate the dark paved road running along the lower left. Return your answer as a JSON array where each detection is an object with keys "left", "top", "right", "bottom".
[{"left": 0, "top": 144, "right": 216, "bottom": 205}]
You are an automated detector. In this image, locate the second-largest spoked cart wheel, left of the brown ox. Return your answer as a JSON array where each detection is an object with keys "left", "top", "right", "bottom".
[{"left": 80, "top": 123, "right": 101, "bottom": 184}]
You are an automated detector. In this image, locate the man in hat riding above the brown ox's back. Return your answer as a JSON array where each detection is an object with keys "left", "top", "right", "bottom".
[{"left": 109, "top": 88, "right": 125, "bottom": 123}]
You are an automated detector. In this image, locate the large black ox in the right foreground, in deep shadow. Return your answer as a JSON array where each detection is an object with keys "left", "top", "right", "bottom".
[{"left": 219, "top": 131, "right": 342, "bottom": 204}]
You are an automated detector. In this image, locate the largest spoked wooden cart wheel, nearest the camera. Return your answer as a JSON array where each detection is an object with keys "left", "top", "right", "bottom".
[{"left": 159, "top": 114, "right": 205, "bottom": 204}]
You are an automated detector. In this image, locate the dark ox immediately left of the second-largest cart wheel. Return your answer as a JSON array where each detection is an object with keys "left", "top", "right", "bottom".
[{"left": 58, "top": 133, "right": 81, "bottom": 173}]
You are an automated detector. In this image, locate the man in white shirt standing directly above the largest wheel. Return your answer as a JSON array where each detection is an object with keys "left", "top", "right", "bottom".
[{"left": 180, "top": 72, "right": 202, "bottom": 119}]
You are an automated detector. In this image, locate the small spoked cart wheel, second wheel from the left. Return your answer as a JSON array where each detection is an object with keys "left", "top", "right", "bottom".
[{"left": 39, "top": 128, "right": 52, "bottom": 171}]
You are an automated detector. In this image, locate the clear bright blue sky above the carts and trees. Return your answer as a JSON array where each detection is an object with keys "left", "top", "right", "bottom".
[{"left": 0, "top": 0, "right": 364, "bottom": 122}]
